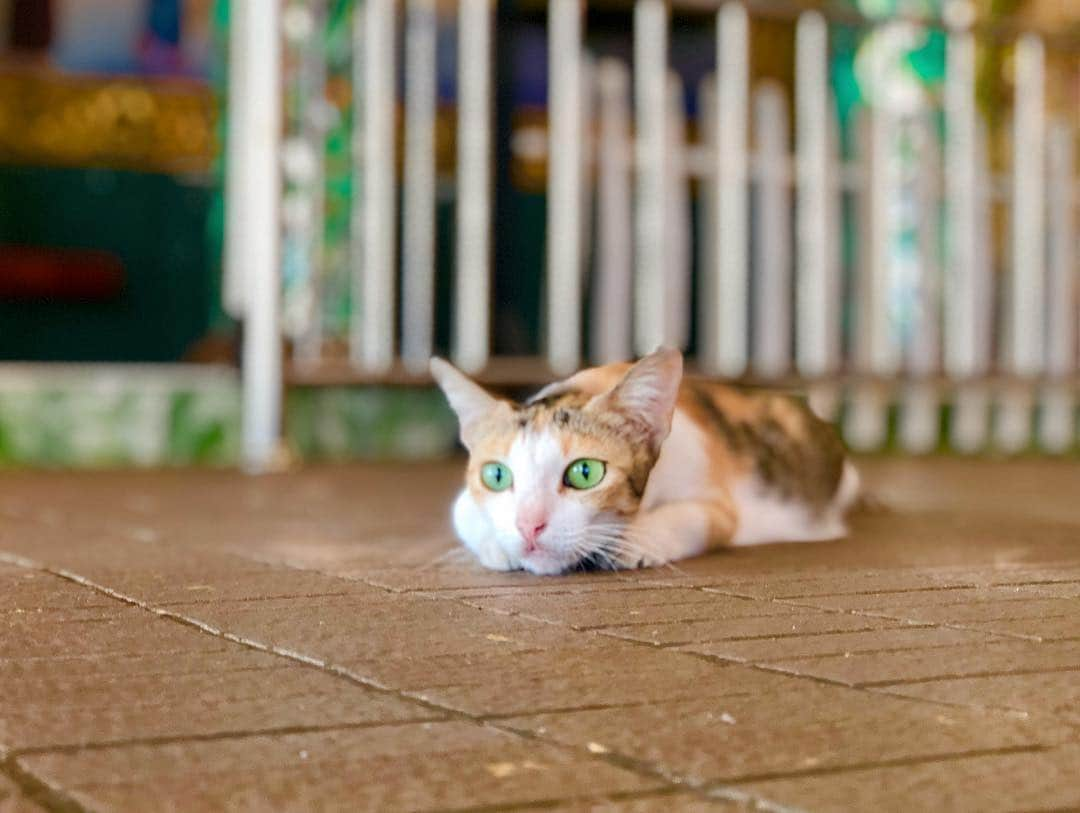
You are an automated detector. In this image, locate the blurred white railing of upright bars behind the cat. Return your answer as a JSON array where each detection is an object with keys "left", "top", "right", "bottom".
[{"left": 227, "top": 0, "right": 1078, "bottom": 468}]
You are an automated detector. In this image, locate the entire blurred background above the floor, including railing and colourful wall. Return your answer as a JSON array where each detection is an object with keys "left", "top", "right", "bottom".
[{"left": 0, "top": 0, "right": 1080, "bottom": 470}]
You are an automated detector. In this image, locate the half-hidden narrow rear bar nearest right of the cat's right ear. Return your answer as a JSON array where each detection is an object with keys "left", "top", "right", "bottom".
[{"left": 697, "top": 73, "right": 719, "bottom": 369}]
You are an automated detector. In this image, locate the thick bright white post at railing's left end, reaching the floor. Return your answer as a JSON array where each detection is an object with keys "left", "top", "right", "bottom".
[{"left": 226, "top": 0, "right": 282, "bottom": 472}]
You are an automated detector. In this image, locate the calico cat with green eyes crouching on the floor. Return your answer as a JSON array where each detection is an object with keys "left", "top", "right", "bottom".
[{"left": 431, "top": 349, "right": 859, "bottom": 574}]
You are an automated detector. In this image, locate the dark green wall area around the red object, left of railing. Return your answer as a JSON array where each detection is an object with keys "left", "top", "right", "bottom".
[{"left": 0, "top": 166, "right": 218, "bottom": 362}]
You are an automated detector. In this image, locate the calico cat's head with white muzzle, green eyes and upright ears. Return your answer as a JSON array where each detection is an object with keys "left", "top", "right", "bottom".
[{"left": 431, "top": 349, "right": 683, "bottom": 574}]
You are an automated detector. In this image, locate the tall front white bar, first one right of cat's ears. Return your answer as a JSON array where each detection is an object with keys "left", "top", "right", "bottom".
[{"left": 714, "top": 2, "right": 750, "bottom": 376}]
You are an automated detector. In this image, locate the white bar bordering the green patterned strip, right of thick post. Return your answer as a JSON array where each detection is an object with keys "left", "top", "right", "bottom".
[{"left": 349, "top": 0, "right": 397, "bottom": 372}]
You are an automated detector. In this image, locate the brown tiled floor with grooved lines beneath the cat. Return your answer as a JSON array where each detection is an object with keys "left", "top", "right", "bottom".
[{"left": 0, "top": 461, "right": 1080, "bottom": 813}]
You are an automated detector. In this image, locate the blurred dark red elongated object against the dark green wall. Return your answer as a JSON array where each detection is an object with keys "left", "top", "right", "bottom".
[{"left": 0, "top": 246, "right": 124, "bottom": 302}]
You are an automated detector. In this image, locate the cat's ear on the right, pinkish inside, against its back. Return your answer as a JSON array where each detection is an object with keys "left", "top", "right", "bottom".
[{"left": 591, "top": 348, "right": 683, "bottom": 450}]
